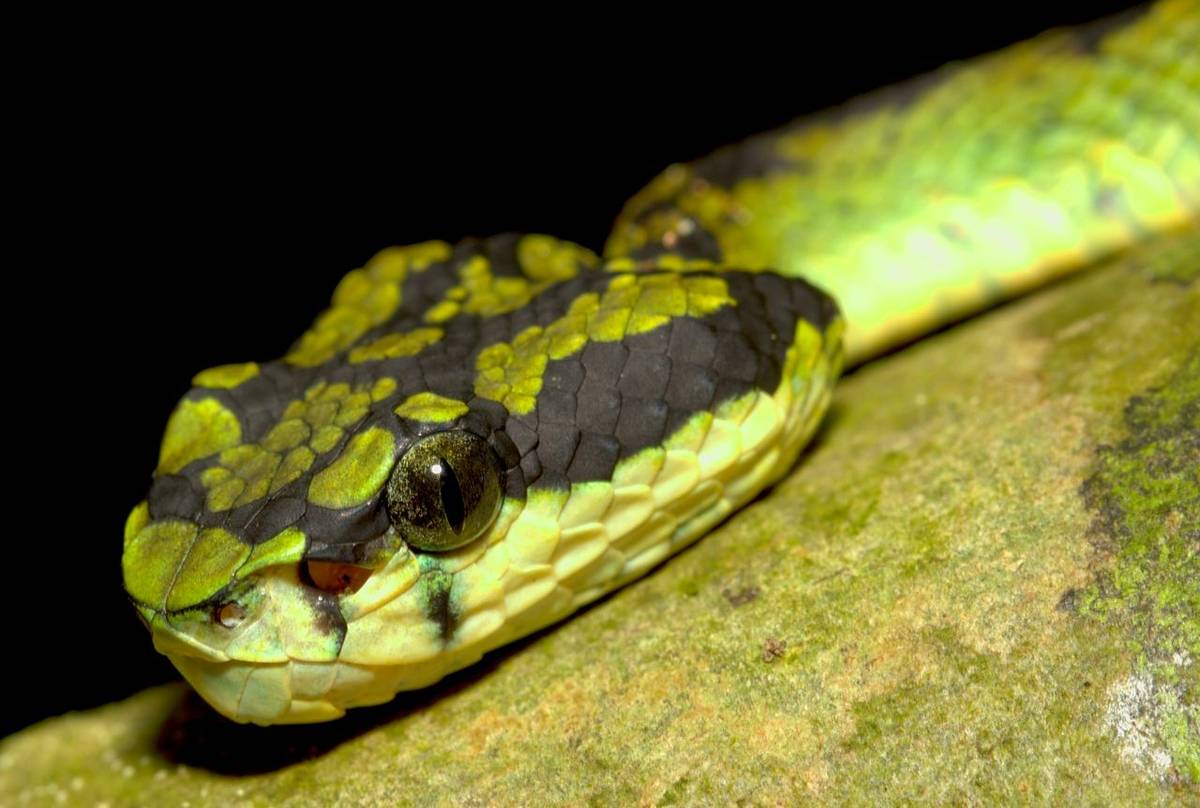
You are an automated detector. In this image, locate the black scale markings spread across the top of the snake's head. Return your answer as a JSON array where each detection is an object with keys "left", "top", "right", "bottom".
[{"left": 142, "top": 237, "right": 835, "bottom": 571}]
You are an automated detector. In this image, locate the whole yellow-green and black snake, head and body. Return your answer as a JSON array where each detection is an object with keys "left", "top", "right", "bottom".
[{"left": 121, "top": 0, "right": 1200, "bottom": 725}]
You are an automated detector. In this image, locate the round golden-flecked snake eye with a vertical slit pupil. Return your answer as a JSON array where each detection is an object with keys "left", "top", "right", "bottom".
[{"left": 388, "top": 431, "right": 502, "bottom": 551}]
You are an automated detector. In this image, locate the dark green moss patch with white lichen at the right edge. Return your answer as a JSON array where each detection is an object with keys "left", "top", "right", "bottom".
[{"left": 1072, "top": 353, "right": 1200, "bottom": 783}]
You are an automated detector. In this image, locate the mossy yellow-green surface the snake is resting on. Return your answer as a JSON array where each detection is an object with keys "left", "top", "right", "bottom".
[{"left": 0, "top": 230, "right": 1200, "bottom": 806}]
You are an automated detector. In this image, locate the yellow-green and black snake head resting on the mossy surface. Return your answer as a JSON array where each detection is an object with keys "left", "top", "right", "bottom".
[{"left": 122, "top": 235, "right": 841, "bottom": 724}]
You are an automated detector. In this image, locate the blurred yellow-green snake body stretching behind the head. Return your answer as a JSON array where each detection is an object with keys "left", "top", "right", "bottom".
[{"left": 606, "top": 0, "right": 1200, "bottom": 364}]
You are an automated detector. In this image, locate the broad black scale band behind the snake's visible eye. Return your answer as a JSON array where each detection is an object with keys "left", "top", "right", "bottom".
[{"left": 520, "top": 273, "right": 836, "bottom": 483}]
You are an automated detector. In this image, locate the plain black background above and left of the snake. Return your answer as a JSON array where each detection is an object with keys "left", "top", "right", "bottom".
[{"left": 9, "top": 2, "right": 1142, "bottom": 735}]
